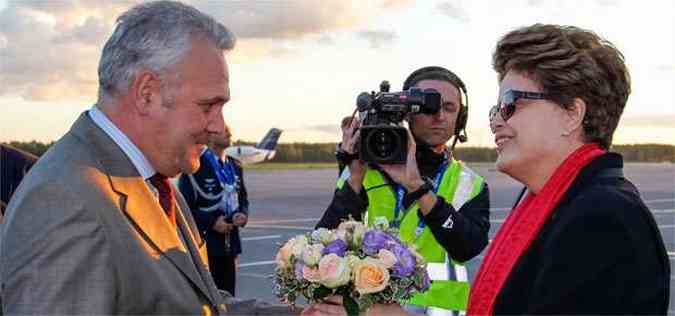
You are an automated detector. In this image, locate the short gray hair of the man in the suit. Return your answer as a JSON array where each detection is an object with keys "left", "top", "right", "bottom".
[{"left": 98, "top": 1, "right": 235, "bottom": 102}]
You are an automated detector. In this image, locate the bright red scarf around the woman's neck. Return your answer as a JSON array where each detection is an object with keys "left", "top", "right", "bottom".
[{"left": 468, "top": 144, "right": 604, "bottom": 315}]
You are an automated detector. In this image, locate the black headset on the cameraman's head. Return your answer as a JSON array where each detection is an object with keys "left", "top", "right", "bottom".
[{"left": 403, "top": 66, "right": 469, "bottom": 149}]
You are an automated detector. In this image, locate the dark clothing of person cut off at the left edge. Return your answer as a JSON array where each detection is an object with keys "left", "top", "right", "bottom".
[{"left": 0, "top": 144, "right": 38, "bottom": 214}]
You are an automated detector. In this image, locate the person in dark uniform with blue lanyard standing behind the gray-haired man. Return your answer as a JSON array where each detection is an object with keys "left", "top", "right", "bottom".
[{"left": 178, "top": 125, "right": 248, "bottom": 295}]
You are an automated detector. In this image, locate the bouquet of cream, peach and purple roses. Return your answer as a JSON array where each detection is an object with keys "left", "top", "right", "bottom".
[{"left": 274, "top": 217, "right": 429, "bottom": 316}]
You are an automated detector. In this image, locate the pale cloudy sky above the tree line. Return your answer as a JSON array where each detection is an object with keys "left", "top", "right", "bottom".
[{"left": 0, "top": 0, "right": 675, "bottom": 146}]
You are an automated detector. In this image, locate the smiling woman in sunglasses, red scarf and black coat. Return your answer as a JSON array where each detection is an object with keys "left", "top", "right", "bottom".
[{"left": 468, "top": 24, "right": 670, "bottom": 315}]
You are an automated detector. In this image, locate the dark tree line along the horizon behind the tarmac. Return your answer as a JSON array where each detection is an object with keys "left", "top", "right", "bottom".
[{"left": 3, "top": 141, "right": 675, "bottom": 163}]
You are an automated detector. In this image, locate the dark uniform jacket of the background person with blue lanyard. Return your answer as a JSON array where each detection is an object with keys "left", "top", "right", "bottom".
[{"left": 178, "top": 154, "right": 249, "bottom": 257}]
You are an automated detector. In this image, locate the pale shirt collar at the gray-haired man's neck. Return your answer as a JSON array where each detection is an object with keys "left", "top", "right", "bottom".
[{"left": 88, "top": 105, "right": 157, "bottom": 179}]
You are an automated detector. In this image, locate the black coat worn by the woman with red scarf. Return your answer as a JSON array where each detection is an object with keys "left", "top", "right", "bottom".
[{"left": 493, "top": 153, "right": 670, "bottom": 315}]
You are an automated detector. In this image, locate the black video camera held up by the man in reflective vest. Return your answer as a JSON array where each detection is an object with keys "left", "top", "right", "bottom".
[{"left": 356, "top": 81, "right": 441, "bottom": 164}]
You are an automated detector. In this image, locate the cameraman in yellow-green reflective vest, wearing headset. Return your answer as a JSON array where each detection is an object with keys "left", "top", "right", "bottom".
[{"left": 316, "top": 67, "right": 490, "bottom": 315}]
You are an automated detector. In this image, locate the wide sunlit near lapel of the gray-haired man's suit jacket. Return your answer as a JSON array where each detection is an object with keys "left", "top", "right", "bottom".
[{"left": 71, "top": 112, "right": 214, "bottom": 303}]
